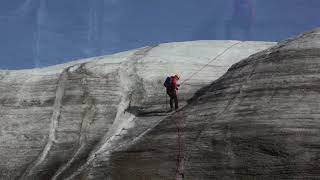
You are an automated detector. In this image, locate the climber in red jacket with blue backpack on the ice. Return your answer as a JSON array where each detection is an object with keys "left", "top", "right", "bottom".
[{"left": 163, "top": 74, "right": 180, "bottom": 111}]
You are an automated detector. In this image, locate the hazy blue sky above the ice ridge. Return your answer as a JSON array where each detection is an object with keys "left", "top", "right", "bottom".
[{"left": 0, "top": 0, "right": 320, "bottom": 69}]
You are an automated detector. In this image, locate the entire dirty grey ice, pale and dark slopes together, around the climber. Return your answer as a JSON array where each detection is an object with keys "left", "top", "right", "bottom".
[{"left": 0, "top": 29, "right": 320, "bottom": 180}]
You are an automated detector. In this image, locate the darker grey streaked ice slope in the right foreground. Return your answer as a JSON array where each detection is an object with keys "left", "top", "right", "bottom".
[{"left": 104, "top": 29, "right": 320, "bottom": 180}]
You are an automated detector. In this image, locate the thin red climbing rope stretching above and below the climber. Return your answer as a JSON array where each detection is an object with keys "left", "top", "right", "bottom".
[{"left": 171, "top": 41, "right": 243, "bottom": 180}]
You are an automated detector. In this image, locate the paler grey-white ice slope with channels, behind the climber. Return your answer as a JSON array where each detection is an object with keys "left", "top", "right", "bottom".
[{"left": 0, "top": 41, "right": 275, "bottom": 180}]
